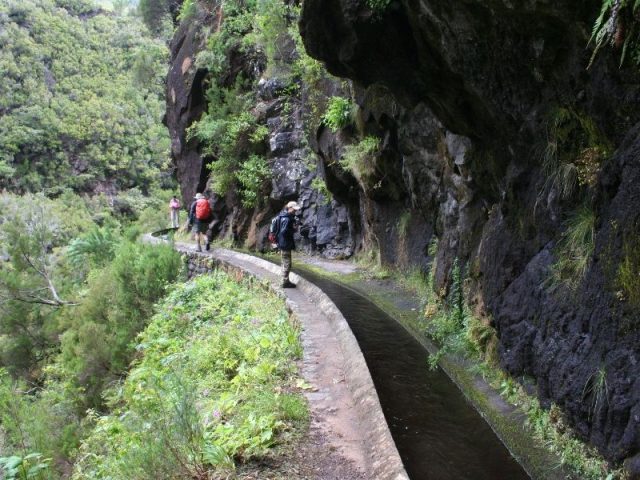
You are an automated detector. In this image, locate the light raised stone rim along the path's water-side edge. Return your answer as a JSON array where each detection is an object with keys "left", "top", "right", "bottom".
[{"left": 144, "top": 235, "right": 409, "bottom": 480}]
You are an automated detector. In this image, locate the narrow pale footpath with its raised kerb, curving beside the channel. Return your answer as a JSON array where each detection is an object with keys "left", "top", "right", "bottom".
[{"left": 162, "top": 236, "right": 409, "bottom": 480}]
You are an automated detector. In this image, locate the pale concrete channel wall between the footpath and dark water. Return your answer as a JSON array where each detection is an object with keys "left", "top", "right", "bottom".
[{"left": 152, "top": 236, "right": 409, "bottom": 480}]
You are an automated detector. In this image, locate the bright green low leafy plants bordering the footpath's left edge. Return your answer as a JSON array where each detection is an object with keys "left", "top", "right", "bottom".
[{"left": 74, "top": 272, "right": 308, "bottom": 479}]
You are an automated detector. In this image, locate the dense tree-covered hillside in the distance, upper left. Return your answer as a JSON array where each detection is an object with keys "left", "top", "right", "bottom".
[{"left": 0, "top": 0, "right": 169, "bottom": 196}]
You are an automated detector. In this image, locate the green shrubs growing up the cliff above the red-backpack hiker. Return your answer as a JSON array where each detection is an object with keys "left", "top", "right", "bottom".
[{"left": 188, "top": 0, "right": 288, "bottom": 208}]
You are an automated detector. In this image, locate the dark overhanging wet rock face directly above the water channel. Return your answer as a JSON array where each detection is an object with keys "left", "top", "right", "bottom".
[{"left": 300, "top": 0, "right": 640, "bottom": 470}]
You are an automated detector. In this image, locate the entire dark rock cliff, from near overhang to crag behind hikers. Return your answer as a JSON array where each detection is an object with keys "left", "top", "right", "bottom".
[{"left": 167, "top": 0, "right": 640, "bottom": 464}]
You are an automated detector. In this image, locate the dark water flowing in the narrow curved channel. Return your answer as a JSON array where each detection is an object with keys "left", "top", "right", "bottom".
[{"left": 300, "top": 271, "right": 529, "bottom": 480}]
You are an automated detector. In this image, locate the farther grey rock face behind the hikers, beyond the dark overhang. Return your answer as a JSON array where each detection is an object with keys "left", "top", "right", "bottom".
[{"left": 165, "top": 10, "right": 357, "bottom": 258}]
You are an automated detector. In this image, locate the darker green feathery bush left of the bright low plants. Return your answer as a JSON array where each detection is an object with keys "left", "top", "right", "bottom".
[{"left": 58, "top": 241, "right": 181, "bottom": 407}]
